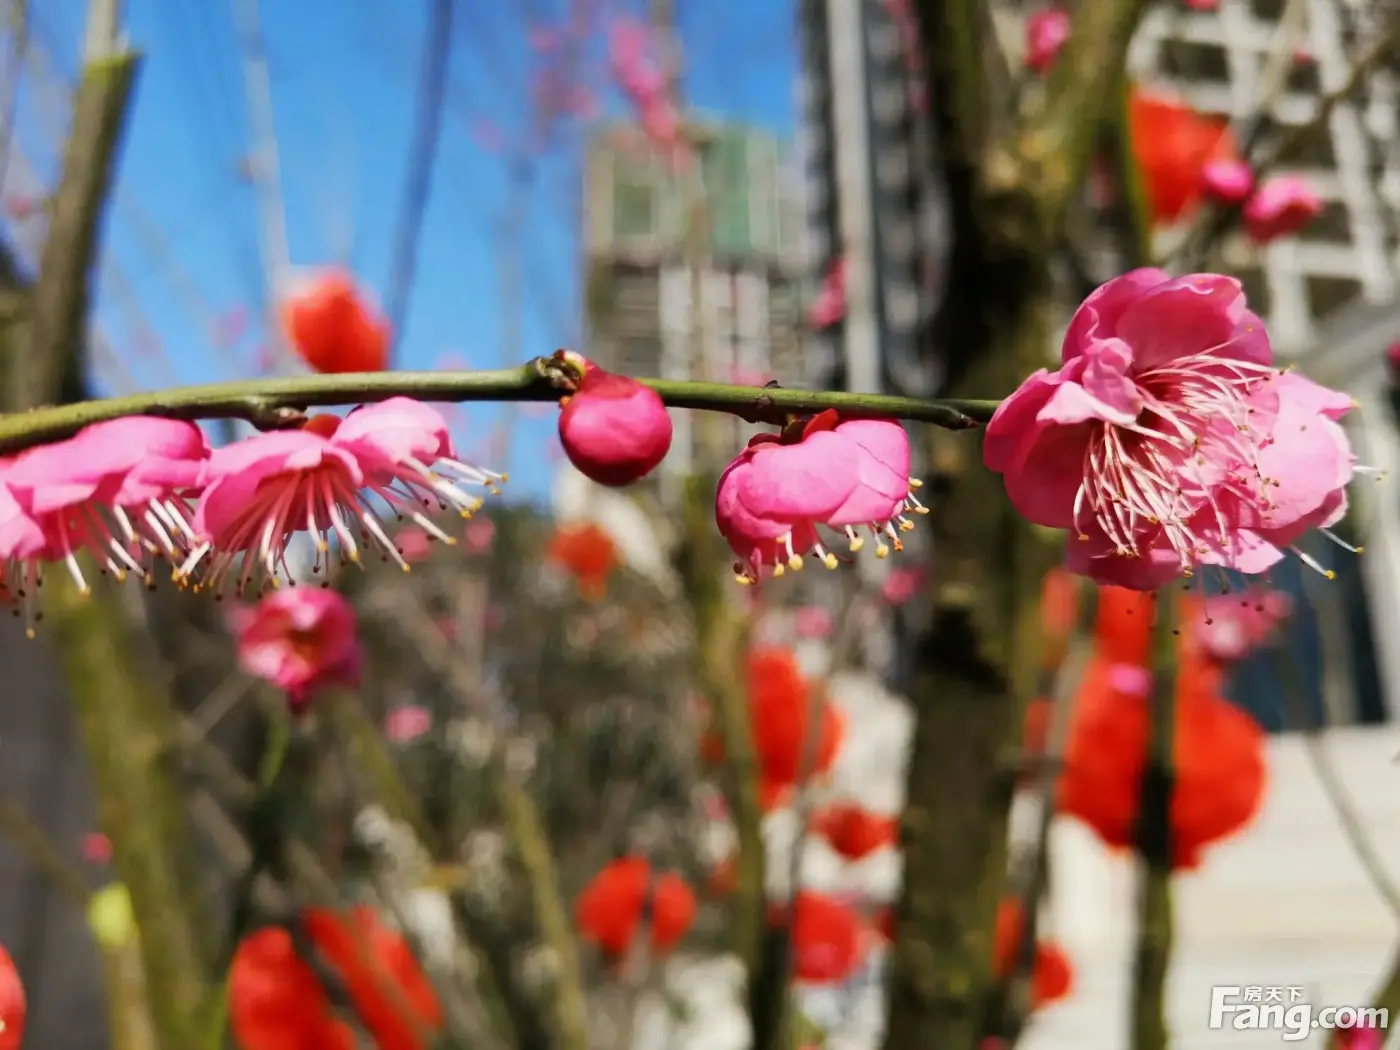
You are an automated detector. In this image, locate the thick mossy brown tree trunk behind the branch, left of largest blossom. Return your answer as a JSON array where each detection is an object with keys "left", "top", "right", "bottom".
[{"left": 885, "top": 0, "right": 1147, "bottom": 1050}]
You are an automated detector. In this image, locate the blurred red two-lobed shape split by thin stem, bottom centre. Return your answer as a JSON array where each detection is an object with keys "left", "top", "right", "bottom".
[{"left": 574, "top": 857, "right": 696, "bottom": 958}]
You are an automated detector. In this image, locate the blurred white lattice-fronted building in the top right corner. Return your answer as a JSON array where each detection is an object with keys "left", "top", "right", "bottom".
[{"left": 1130, "top": 0, "right": 1400, "bottom": 358}]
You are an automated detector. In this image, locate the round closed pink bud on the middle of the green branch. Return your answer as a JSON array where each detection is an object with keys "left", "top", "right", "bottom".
[{"left": 559, "top": 353, "right": 672, "bottom": 487}]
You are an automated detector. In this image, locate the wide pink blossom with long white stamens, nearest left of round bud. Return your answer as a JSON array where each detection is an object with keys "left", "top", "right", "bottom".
[{"left": 176, "top": 398, "right": 505, "bottom": 592}]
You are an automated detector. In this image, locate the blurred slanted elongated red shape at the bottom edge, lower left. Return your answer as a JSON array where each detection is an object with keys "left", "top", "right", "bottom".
[{"left": 301, "top": 906, "right": 442, "bottom": 1050}]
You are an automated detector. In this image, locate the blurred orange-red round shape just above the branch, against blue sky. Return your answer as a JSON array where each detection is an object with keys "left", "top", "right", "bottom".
[{"left": 281, "top": 269, "right": 389, "bottom": 372}]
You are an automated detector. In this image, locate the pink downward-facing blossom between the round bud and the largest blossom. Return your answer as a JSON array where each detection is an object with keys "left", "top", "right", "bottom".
[{"left": 715, "top": 410, "right": 925, "bottom": 584}]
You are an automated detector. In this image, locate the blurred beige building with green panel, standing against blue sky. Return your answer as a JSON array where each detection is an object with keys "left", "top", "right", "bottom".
[{"left": 582, "top": 125, "right": 809, "bottom": 476}]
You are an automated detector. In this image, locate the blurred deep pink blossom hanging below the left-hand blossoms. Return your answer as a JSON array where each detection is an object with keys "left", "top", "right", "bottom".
[{"left": 230, "top": 587, "right": 364, "bottom": 714}]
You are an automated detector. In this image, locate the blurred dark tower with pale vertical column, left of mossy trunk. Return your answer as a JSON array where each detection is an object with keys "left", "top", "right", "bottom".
[{"left": 798, "top": 0, "right": 945, "bottom": 396}]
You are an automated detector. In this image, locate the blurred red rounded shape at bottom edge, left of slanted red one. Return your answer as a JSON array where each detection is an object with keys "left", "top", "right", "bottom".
[{"left": 228, "top": 927, "right": 356, "bottom": 1050}]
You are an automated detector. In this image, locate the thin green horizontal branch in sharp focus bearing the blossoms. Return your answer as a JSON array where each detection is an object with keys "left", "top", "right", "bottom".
[{"left": 0, "top": 357, "right": 997, "bottom": 452}]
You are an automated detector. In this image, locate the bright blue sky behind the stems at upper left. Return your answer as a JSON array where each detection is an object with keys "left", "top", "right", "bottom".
[{"left": 6, "top": 0, "right": 795, "bottom": 496}]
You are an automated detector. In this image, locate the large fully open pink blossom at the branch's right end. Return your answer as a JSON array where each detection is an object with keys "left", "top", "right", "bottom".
[{"left": 983, "top": 269, "right": 1355, "bottom": 591}]
